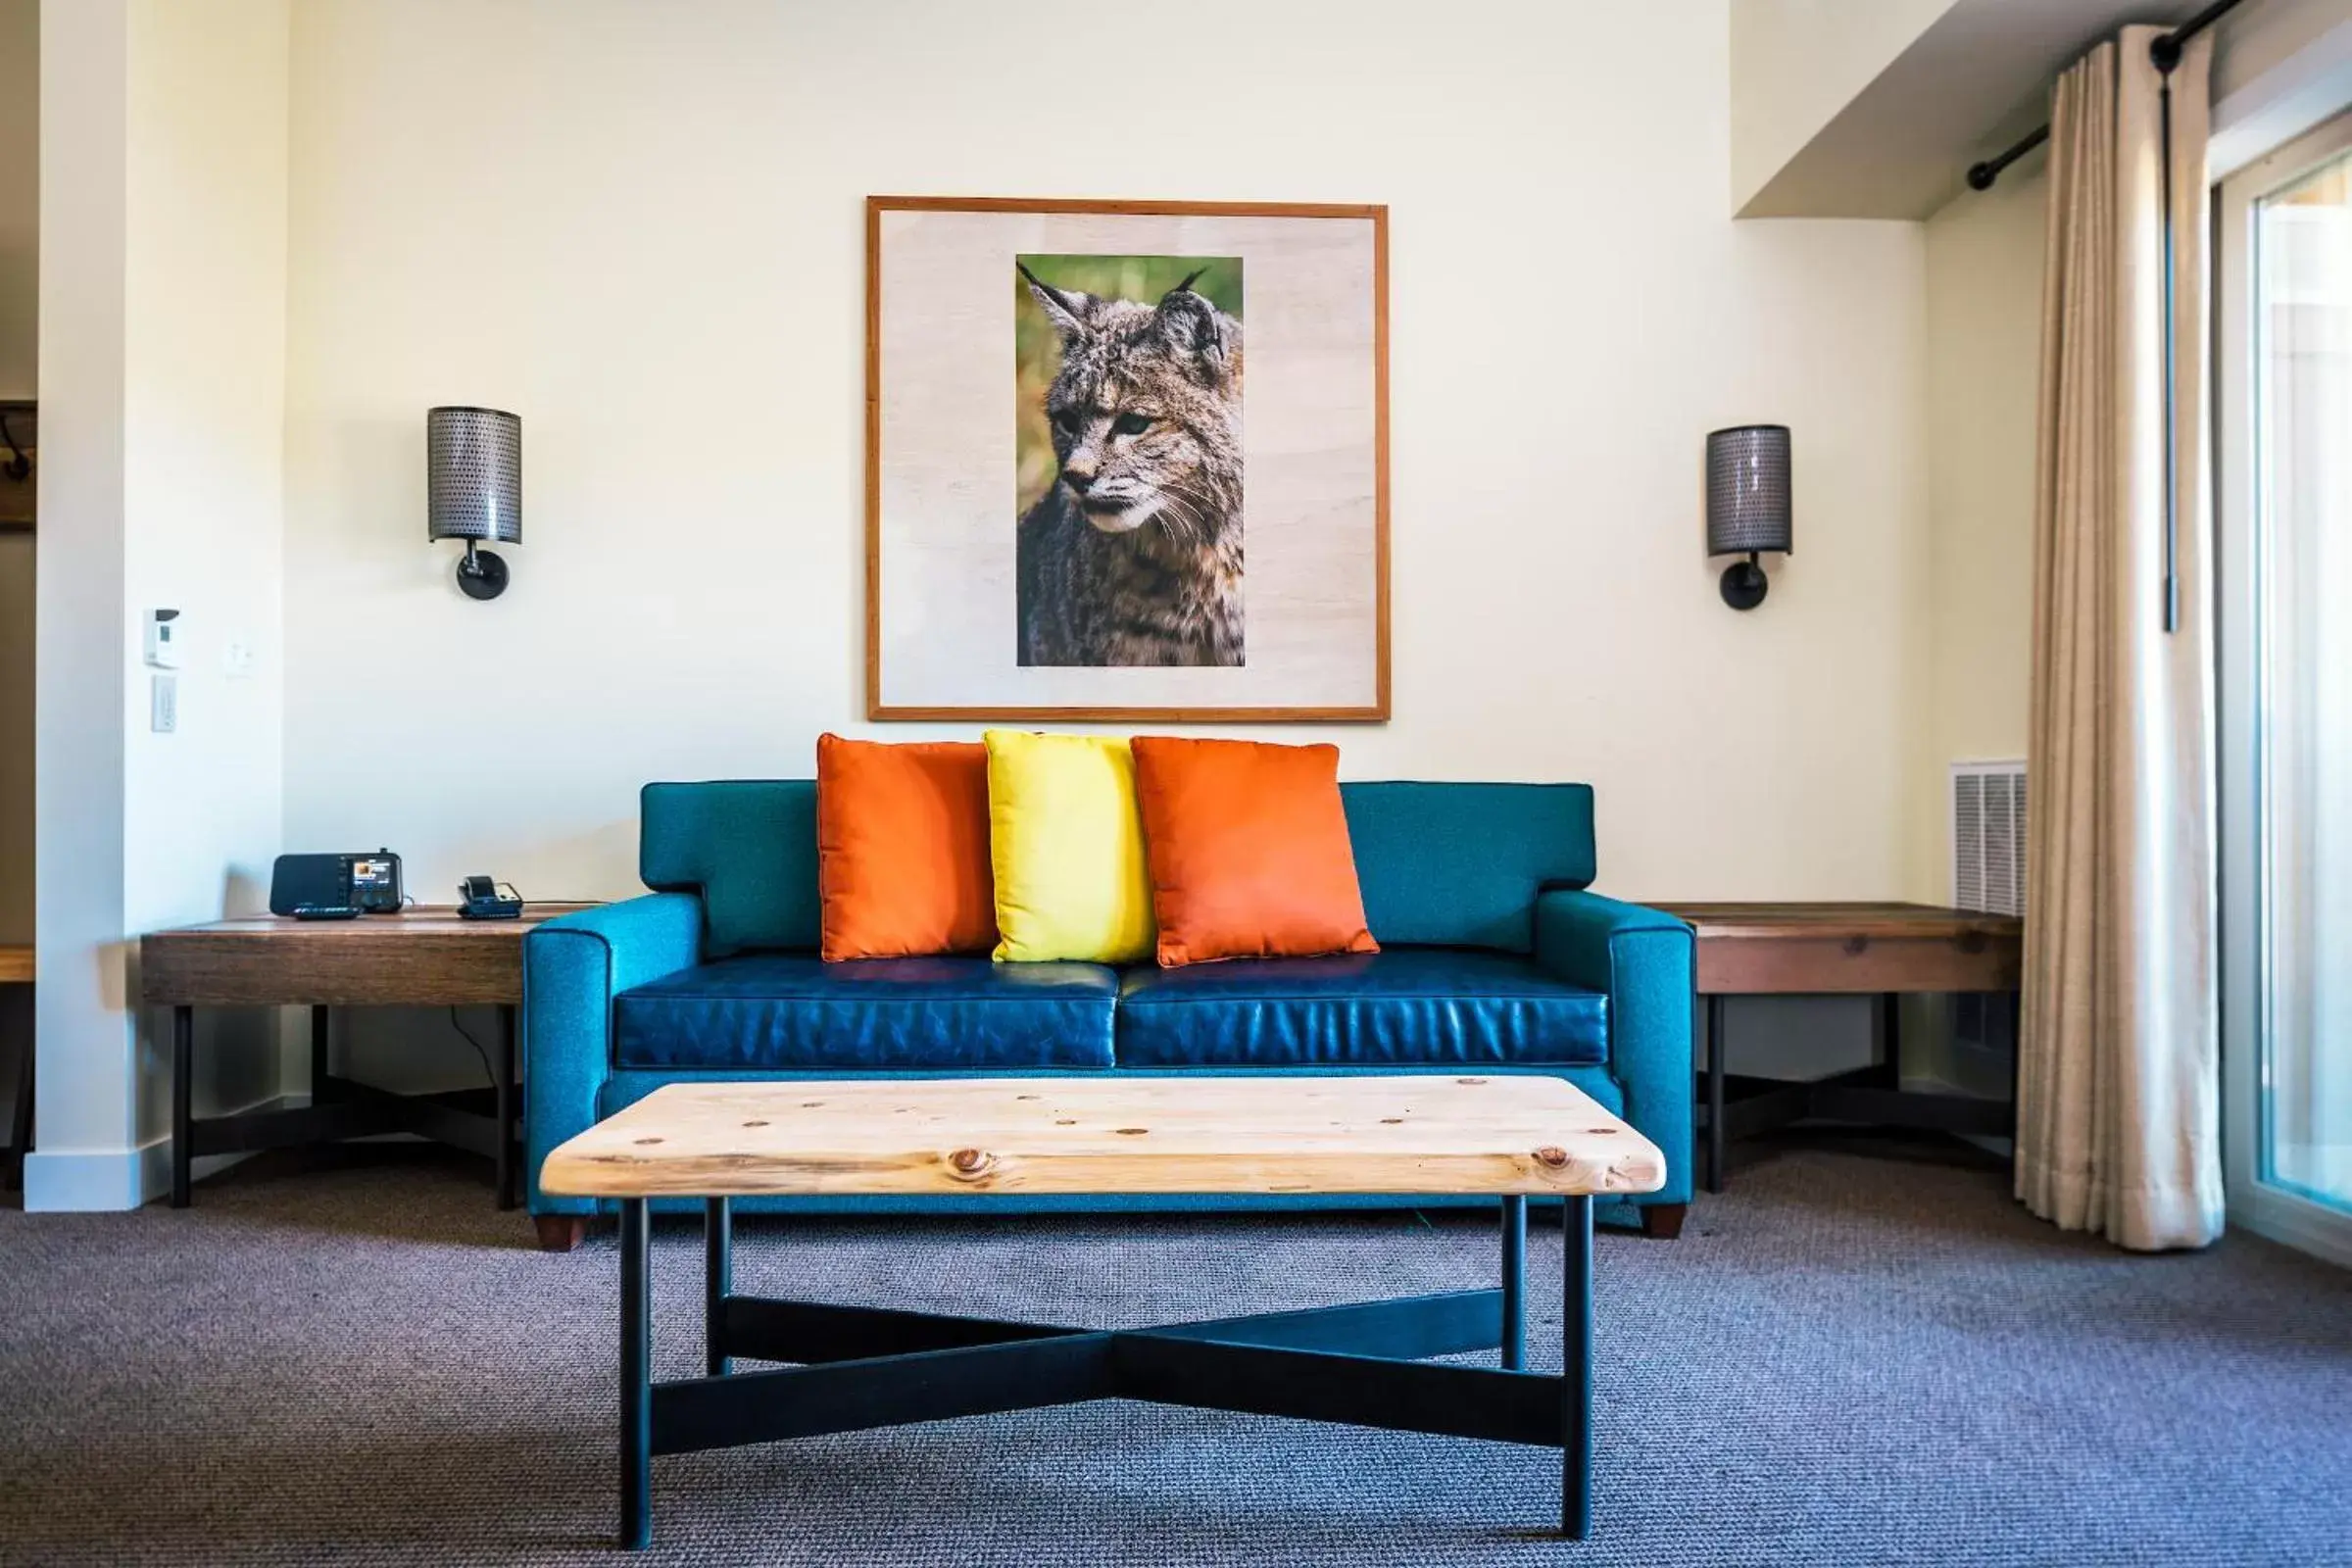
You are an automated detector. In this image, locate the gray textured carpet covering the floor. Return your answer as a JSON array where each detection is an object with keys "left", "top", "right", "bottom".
[{"left": 0, "top": 1150, "right": 2352, "bottom": 1568}]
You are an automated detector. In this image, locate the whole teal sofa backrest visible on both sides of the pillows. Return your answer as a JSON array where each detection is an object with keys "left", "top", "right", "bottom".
[{"left": 637, "top": 778, "right": 1592, "bottom": 959}]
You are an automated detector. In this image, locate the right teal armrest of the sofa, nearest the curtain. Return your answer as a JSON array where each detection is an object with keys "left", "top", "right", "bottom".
[{"left": 1536, "top": 889, "right": 1698, "bottom": 1203}]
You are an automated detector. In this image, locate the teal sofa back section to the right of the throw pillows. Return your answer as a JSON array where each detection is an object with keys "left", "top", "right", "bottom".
[{"left": 1339, "top": 783, "right": 1592, "bottom": 953}]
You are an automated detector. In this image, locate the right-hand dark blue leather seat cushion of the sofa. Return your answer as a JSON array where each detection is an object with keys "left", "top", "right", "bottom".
[{"left": 1117, "top": 948, "right": 1609, "bottom": 1067}]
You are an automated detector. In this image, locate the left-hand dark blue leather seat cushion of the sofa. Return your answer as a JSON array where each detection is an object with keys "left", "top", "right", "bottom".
[{"left": 612, "top": 953, "right": 1117, "bottom": 1072}]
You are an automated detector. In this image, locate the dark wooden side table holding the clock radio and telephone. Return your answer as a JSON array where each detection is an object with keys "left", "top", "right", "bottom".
[{"left": 139, "top": 903, "right": 588, "bottom": 1208}]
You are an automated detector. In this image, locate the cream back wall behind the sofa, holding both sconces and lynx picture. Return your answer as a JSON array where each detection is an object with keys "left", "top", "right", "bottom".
[{"left": 287, "top": 0, "right": 1927, "bottom": 921}]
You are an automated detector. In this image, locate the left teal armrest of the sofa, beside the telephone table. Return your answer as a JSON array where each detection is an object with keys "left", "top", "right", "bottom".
[{"left": 522, "top": 894, "right": 704, "bottom": 1213}]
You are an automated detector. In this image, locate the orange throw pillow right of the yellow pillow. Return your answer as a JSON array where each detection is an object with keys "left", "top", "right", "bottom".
[{"left": 1136, "top": 736, "right": 1381, "bottom": 968}]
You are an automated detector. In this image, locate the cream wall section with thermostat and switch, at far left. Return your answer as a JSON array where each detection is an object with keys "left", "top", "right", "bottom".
[{"left": 25, "top": 0, "right": 289, "bottom": 1208}]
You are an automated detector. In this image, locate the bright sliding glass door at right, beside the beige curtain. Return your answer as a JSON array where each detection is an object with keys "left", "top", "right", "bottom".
[{"left": 2216, "top": 116, "right": 2352, "bottom": 1262}]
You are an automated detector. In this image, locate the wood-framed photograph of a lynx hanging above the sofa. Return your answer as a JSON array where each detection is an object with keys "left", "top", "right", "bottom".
[{"left": 865, "top": 195, "right": 1388, "bottom": 721}]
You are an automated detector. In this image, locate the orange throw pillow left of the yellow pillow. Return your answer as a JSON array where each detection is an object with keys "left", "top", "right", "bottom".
[{"left": 816, "top": 736, "right": 998, "bottom": 961}]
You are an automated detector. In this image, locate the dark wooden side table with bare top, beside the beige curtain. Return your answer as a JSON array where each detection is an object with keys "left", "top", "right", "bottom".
[{"left": 1658, "top": 903, "right": 2025, "bottom": 1192}]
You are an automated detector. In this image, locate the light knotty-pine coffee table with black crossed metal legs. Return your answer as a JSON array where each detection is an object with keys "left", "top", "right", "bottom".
[{"left": 539, "top": 1074, "right": 1665, "bottom": 1549}]
